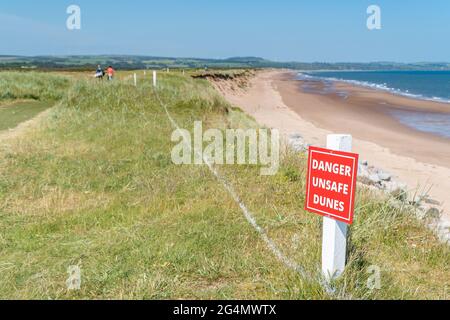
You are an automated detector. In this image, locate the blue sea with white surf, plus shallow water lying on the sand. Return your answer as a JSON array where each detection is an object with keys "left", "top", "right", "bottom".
[{"left": 298, "top": 71, "right": 450, "bottom": 139}]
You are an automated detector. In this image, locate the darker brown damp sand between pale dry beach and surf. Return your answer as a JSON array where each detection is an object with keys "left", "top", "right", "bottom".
[{"left": 275, "top": 73, "right": 450, "bottom": 167}]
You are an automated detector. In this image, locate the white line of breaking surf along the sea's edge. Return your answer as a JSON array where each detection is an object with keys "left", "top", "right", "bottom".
[{"left": 297, "top": 73, "right": 450, "bottom": 104}]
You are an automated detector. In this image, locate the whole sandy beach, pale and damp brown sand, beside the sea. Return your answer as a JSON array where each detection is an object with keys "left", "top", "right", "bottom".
[{"left": 216, "top": 71, "right": 450, "bottom": 225}]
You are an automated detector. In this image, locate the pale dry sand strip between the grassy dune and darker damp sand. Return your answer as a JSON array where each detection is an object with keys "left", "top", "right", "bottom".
[{"left": 213, "top": 71, "right": 450, "bottom": 226}]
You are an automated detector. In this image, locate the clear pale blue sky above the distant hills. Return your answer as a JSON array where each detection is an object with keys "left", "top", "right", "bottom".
[{"left": 0, "top": 0, "right": 450, "bottom": 62}]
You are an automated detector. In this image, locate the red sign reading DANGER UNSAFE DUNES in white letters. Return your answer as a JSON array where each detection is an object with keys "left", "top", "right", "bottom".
[{"left": 305, "top": 147, "right": 359, "bottom": 224}]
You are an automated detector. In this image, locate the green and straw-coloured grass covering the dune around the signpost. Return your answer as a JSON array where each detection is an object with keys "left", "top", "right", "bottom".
[{"left": 0, "top": 73, "right": 450, "bottom": 299}]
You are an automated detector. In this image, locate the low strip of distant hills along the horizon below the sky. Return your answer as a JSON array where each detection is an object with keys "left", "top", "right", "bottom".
[{"left": 0, "top": 55, "right": 450, "bottom": 70}]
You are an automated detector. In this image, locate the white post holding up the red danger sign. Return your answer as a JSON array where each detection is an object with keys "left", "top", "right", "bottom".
[{"left": 322, "top": 134, "right": 352, "bottom": 281}]
